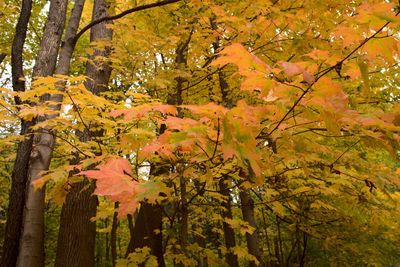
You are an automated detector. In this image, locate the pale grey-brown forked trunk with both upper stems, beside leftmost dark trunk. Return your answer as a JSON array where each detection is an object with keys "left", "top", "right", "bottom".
[{"left": 11, "top": 0, "right": 83, "bottom": 266}]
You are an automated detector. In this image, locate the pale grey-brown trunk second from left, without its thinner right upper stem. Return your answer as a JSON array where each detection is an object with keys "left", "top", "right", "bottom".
[{"left": 17, "top": 0, "right": 68, "bottom": 267}]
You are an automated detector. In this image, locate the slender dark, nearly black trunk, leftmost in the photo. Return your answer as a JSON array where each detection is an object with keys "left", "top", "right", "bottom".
[{"left": 0, "top": 0, "right": 33, "bottom": 267}]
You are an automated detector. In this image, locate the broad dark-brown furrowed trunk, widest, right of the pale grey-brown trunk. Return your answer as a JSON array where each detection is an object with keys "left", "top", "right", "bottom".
[{"left": 55, "top": 0, "right": 112, "bottom": 267}]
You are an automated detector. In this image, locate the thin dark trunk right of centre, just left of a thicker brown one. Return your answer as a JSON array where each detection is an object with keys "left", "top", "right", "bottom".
[{"left": 219, "top": 179, "right": 239, "bottom": 267}]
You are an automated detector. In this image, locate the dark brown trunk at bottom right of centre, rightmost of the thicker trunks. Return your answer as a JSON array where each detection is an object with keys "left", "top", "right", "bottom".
[{"left": 239, "top": 189, "right": 264, "bottom": 267}]
